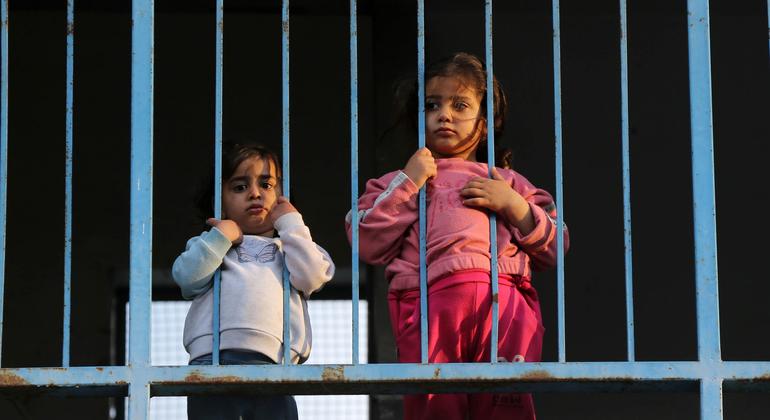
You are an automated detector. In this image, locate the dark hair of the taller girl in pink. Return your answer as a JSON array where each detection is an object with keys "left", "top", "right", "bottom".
[{"left": 396, "top": 52, "right": 513, "bottom": 168}]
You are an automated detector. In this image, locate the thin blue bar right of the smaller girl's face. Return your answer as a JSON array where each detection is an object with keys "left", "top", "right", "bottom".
[{"left": 281, "top": 0, "right": 291, "bottom": 365}]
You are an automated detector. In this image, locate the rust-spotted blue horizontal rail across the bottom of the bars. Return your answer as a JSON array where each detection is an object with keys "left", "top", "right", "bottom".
[{"left": 0, "top": 361, "right": 770, "bottom": 394}]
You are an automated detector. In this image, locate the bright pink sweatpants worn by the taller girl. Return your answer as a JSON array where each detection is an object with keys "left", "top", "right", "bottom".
[{"left": 388, "top": 271, "right": 543, "bottom": 420}]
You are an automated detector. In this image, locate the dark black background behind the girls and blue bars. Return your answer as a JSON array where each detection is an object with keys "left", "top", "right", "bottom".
[{"left": 0, "top": 0, "right": 770, "bottom": 419}]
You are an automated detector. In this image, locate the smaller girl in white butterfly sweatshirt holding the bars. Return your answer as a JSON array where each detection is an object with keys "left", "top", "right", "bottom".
[{"left": 172, "top": 145, "right": 334, "bottom": 419}]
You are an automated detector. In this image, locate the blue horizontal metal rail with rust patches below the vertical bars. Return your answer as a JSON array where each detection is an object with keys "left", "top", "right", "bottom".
[{"left": 0, "top": 361, "right": 770, "bottom": 396}]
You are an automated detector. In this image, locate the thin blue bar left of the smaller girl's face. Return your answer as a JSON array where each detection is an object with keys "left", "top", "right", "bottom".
[{"left": 211, "top": 0, "right": 225, "bottom": 365}]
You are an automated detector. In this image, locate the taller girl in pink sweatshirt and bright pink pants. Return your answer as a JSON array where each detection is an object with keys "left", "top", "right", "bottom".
[{"left": 346, "top": 53, "right": 568, "bottom": 420}]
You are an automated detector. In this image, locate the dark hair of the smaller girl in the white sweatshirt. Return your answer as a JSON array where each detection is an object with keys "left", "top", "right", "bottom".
[{"left": 197, "top": 143, "right": 281, "bottom": 225}]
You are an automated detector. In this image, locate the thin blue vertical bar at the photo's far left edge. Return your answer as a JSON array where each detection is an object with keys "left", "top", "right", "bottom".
[{"left": 0, "top": 0, "right": 8, "bottom": 366}]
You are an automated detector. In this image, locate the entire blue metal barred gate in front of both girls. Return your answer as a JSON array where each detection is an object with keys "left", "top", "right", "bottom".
[{"left": 0, "top": 0, "right": 770, "bottom": 420}]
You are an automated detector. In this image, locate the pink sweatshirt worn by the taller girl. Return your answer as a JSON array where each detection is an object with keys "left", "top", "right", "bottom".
[{"left": 345, "top": 158, "right": 569, "bottom": 290}]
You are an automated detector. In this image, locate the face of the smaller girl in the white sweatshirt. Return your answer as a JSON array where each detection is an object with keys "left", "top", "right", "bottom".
[{"left": 222, "top": 156, "right": 278, "bottom": 237}]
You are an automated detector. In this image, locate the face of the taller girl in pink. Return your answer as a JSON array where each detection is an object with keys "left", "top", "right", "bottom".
[{"left": 425, "top": 76, "right": 484, "bottom": 162}]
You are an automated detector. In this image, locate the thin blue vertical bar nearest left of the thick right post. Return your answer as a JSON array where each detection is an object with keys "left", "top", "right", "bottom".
[{"left": 620, "top": 0, "right": 636, "bottom": 362}]
